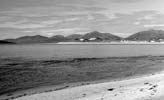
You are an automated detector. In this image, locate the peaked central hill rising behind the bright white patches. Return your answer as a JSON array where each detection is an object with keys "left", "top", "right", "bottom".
[{"left": 82, "top": 31, "right": 121, "bottom": 41}]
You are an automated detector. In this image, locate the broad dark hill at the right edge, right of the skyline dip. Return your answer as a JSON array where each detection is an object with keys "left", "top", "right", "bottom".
[{"left": 126, "top": 30, "right": 164, "bottom": 41}]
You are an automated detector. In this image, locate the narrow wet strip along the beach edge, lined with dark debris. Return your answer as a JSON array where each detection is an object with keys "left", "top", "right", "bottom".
[{"left": 0, "top": 71, "right": 164, "bottom": 100}]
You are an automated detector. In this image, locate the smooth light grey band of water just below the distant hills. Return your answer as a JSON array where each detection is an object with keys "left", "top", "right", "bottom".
[{"left": 0, "top": 44, "right": 164, "bottom": 58}]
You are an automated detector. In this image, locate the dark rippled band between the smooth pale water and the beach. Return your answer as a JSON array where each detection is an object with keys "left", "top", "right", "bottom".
[{"left": 0, "top": 56, "right": 164, "bottom": 95}]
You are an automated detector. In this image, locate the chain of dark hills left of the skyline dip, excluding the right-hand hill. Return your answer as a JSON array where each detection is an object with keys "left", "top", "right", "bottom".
[{"left": 4, "top": 31, "right": 121, "bottom": 43}]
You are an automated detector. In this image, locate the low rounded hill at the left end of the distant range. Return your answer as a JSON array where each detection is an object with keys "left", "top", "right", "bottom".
[{"left": 6, "top": 35, "right": 48, "bottom": 43}]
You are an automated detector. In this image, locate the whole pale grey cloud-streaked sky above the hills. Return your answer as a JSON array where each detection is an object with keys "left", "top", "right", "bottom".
[{"left": 0, "top": 0, "right": 164, "bottom": 39}]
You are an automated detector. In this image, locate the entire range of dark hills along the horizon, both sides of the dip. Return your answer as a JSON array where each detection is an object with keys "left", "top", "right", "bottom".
[{"left": 3, "top": 29, "right": 164, "bottom": 43}]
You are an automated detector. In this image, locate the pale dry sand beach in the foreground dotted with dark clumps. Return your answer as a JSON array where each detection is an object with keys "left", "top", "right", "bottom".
[{"left": 14, "top": 72, "right": 164, "bottom": 100}]
